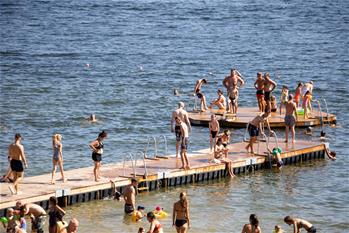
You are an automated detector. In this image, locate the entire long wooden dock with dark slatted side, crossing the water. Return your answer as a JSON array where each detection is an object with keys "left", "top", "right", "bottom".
[{"left": 0, "top": 138, "right": 326, "bottom": 214}]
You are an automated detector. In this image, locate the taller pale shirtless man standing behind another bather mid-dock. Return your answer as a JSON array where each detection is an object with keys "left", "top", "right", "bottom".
[{"left": 171, "top": 102, "right": 191, "bottom": 158}]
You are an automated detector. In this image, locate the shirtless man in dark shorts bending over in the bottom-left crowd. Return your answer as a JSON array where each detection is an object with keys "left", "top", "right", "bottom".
[{"left": 21, "top": 202, "right": 46, "bottom": 233}]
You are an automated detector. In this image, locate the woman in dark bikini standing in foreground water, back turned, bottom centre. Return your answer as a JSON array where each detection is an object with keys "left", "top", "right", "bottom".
[{"left": 172, "top": 192, "right": 190, "bottom": 233}]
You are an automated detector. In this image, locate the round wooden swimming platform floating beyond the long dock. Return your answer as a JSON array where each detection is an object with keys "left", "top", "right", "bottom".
[{"left": 188, "top": 107, "right": 337, "bottom": 128}]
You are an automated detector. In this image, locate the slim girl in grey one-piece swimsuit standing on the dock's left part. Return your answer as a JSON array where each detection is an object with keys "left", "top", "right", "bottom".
[{"left": 51, "top": 134, "right": 67, "bottom": 184}]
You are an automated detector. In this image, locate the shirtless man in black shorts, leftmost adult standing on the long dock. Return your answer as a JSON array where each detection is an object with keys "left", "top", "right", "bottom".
[{"left": 8, "top": 133, "right": 28, "bottom": 194}]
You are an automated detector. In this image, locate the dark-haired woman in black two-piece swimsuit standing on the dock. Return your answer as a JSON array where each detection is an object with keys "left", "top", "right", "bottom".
[{"left": 90, "top": 130, "right": 107, "bottom": 182}]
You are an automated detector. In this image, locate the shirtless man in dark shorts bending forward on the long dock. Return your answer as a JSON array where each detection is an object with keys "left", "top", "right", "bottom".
[{"left": 245, "top": 113, "right": 272, "bottom": 154}]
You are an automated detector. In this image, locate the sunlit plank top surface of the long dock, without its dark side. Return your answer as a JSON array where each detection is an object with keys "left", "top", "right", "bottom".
[{"left": 0, "top": 141, "right": 325, "bottom": 209}]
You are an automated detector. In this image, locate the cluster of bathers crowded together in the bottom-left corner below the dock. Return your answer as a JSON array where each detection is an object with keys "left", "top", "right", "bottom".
[{"left": 2, "top": 196, "right": 79, "bottom": 233}]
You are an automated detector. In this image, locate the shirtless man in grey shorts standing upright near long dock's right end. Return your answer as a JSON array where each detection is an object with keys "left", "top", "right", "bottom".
[{"left": 285, "top": 95, "right": 298, "bottom": 143}]
